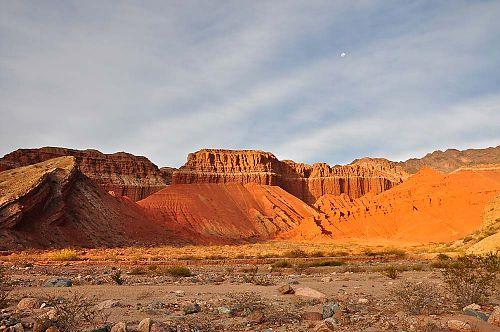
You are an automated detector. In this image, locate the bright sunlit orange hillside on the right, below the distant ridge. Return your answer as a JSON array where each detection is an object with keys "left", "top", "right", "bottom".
[{"left": 280, "top": 167, "right": 500, "bottom": 244}]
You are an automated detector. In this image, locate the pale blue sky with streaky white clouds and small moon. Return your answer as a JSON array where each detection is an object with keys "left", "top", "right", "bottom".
[{"left": 0, "top": 0, "right": 500, "bottom": 167}]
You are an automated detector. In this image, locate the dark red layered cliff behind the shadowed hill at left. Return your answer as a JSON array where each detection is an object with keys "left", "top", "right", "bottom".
[{"left": 0, "top": 147, "right": 171, "bottom": 201}]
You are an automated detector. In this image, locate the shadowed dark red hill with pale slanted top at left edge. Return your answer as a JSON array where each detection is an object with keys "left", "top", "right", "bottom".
[{"left": 0, "top": 157, "right": 180, "bottom": 249}]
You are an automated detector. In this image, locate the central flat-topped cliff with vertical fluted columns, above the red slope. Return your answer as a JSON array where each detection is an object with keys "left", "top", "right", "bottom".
[{"left": 172, "top": 149, "right": 408, "bottom": 204}]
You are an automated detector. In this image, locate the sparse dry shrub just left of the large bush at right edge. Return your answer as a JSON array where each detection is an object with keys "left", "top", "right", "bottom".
[{"left": 392, "top": 281, "right": 442, "bottom": 315}]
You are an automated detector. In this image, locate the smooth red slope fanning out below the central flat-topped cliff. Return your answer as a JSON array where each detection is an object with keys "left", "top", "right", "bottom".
[{"left": 138, "top": 183, "right": 315, "bottom": 243}]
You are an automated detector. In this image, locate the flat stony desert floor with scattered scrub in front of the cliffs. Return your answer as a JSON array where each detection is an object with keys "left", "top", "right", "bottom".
[{"left": 0, "top": 243, "right": 500, "bottom": 331}]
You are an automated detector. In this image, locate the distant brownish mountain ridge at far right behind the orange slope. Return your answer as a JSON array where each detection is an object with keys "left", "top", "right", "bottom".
[{"left": 397, "top": 145, "right": 500, "bottom": 174}]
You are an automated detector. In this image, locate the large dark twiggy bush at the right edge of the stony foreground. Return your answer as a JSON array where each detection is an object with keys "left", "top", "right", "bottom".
[{"left": 443, "top": 253, "right": 500, "bottom": 306}]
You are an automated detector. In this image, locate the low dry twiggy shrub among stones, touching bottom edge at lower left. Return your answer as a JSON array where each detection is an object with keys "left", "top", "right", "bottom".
[{"left": 47, "top": 294, "right": 109, "bottom": 332}]
